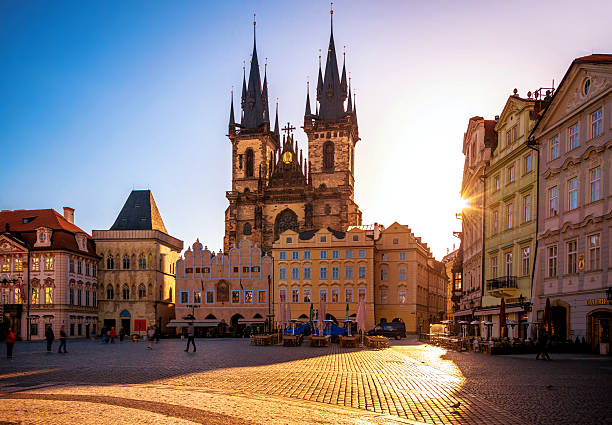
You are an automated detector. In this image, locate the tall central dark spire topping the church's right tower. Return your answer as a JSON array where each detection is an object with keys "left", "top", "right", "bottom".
[{"left": 319, "top": 5, "right": 344, "bottom": 120}]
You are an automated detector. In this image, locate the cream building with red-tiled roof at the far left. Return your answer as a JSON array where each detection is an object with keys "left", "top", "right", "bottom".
[{"left": 0, "top": 207, "right": 98, "bottom": 340}]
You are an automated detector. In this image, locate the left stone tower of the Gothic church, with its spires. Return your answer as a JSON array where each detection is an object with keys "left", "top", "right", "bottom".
[{"left": 223, "top": 21, "right": 280, "bottom": 251}]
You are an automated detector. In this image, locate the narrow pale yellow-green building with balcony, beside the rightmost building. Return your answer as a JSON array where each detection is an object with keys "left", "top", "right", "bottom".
[{"left": 482, "top": 90, "right": 538, "bottom": 337}]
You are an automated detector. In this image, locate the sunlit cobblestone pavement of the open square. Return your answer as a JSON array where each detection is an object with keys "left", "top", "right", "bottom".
[{"left": 0, "top": 339, "right": 612, "bottom": 424}]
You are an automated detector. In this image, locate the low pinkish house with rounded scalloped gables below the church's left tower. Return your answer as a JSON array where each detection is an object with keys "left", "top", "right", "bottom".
[{"left": 169, "top": 240, "right": 273, "bottom": 335}]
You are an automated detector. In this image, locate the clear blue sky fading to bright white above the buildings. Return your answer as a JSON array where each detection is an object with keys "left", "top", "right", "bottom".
[{"left": 0, "top": 0, "right": 612, "bottom": 258}]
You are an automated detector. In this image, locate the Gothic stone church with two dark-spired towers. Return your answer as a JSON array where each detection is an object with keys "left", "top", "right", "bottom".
[{"left": 223, "top": 14, "right": 361, "bottom": 253}]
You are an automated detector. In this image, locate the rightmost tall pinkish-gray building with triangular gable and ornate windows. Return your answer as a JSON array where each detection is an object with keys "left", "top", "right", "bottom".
[{"left": 532, "top": 55, "right": 612, "bottom": 353}]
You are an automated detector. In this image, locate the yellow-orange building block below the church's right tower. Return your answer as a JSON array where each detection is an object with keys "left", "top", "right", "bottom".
[{"left": 273, "top": 223, "right": 446, "bottom": 333}]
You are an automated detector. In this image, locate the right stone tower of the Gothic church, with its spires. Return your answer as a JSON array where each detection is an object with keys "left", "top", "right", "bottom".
[{"left": 303, "top": 6, "right": 361, "bottom": 225}]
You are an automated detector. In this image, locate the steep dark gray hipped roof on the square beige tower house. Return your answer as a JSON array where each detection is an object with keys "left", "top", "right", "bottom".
[{"left": 110, "top": 190, "right": 168, "bottom": 234}]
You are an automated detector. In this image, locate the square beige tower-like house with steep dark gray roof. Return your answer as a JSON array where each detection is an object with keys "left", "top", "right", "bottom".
[{"left": 93, "top": 190, "right": 183, "bottom": 335}]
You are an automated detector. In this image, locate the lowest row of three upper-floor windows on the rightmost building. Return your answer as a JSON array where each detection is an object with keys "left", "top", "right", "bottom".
[{"left": 546, "top": 233, "right": 601, "bottom": 277}]
